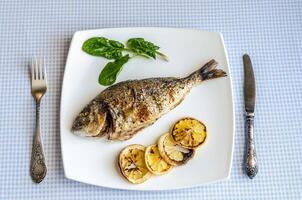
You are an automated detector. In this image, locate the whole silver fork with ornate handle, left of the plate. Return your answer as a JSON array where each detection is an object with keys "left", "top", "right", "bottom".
[{"left": 30, "top": 59, "right": 47, "bottom": 183}]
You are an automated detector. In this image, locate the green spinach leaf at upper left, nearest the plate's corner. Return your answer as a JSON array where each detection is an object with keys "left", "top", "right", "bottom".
[{"left": 82, "top": 37, "right": 124, "bottom": 59}]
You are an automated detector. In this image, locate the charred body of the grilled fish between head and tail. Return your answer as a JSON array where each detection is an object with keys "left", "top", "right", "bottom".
[{"left": 99, "top": 78, "right": 190, "bottom": 140}]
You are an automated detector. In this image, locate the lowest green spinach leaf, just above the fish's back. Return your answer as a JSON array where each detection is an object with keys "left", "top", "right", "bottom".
[{"left": 99, "top": 54, "right": 130, "bottom": 86}]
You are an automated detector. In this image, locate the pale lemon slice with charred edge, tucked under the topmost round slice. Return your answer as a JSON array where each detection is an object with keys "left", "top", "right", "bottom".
[{"left": 157, "top": 133, "right": 195, "bottom": 166}]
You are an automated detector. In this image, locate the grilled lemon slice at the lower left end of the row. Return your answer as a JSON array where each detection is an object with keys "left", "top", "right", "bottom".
[{"left": 118, "top": 144, "right": 151, "bottom": 184}]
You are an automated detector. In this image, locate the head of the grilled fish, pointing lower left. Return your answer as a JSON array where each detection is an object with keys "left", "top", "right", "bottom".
[{"left": 71, "top": 103, "right": 108, "bottom": 137}]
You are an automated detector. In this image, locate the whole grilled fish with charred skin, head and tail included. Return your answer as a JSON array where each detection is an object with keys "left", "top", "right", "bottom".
[{"left": 71, "top": 60, "right": 226, "bottom": 140}]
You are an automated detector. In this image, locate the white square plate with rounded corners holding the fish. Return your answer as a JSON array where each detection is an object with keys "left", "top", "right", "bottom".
[{"left": 60, "top": 28, "right": 234, "bottom": 190}]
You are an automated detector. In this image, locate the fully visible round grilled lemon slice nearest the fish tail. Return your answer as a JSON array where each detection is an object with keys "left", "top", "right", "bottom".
[{"left": 171, "top": 118, "right": 207, "bottom": 149}]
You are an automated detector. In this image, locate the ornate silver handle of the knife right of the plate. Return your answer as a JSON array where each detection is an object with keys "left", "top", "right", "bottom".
[{"left": 245, "top": 113, "right": 258, "bottom": 179}]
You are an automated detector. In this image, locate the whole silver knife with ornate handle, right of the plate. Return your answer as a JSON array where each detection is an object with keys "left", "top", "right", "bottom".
[{"left": 243, "top": 54, "right": 258, "bottom": 179}]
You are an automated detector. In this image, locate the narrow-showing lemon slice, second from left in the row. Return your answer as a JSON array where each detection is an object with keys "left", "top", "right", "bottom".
[{"left": 145, "top": 144, "right": 172, "bottom": 175}]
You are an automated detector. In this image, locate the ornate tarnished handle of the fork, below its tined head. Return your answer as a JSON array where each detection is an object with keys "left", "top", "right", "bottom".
[{"left": 30, "top": 101, "right": 47, "bottom": 183}]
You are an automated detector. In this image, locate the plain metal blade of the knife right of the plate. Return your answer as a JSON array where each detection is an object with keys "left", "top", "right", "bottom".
[{"left": 243, "top": 54, "right": 256, "bottom": 113}]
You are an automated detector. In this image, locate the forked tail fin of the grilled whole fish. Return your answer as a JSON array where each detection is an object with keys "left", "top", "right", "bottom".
[{"left": 187, "top": 59, "right": 227, "bottom": 83}]
